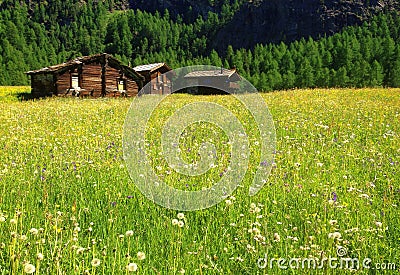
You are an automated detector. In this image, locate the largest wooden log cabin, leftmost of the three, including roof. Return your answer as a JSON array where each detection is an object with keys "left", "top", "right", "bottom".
[{"left": 27, "top": 53, "right": 145, "bottom": 97}]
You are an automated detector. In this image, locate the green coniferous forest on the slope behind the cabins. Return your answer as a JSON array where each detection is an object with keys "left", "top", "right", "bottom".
[{"left": 0, "top": 0, "right": 400, "bottom": 91}]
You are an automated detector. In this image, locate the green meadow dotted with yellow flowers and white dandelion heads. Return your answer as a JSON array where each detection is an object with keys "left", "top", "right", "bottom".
[{"left": 0, "top": 87, "right": 400, "bottom": 274}]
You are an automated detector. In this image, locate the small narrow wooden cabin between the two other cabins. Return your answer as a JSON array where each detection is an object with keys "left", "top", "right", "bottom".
[{"left": 133, "top": 63, "right": 171, "bottom": 95}]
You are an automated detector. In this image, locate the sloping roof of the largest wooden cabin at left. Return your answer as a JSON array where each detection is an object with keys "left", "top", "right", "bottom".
[{"left": 26, "top": 53, "right": 144, "bottom": 80}]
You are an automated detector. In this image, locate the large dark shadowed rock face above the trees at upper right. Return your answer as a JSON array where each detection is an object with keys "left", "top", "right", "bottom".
[{"left": 215, "top": 0, "right": 379, "bottom": 48}]
